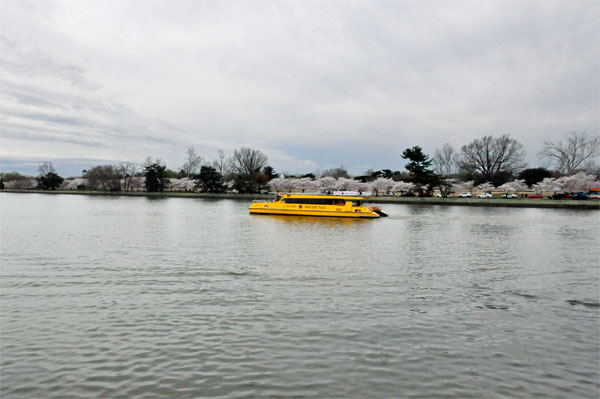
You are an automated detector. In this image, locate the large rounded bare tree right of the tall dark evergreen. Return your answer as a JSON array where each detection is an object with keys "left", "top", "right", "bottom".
[{"left": 458, "top": 134, "right": 525, "bottom": 181}]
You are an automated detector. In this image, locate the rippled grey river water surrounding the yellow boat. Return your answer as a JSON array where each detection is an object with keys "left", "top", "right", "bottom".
[{"left": 0, "top": 193, "right": 600, "bottom": 398}]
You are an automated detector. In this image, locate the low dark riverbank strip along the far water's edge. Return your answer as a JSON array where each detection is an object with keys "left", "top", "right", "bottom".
[{"left": 0, "top": 189, "right": 600, "bottom": 210}]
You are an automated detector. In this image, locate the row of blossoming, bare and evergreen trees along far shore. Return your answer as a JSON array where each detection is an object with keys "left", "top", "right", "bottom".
[{"left": 0, "top": 132, "right": 600, "bottom": 196}]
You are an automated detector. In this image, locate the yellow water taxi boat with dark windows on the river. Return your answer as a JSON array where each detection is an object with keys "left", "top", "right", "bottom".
[{"left": 249, "top": 191, "right": 387, "bottom": 218}]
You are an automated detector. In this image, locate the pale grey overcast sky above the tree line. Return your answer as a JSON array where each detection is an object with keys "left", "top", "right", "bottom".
[{"left": 0, "top": 0, "right": 600, "bottom": 175}]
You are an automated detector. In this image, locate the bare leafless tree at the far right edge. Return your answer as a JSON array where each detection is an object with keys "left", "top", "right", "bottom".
[{"left": 539, "top": 132, "right": 600, "bottom": 175}]
